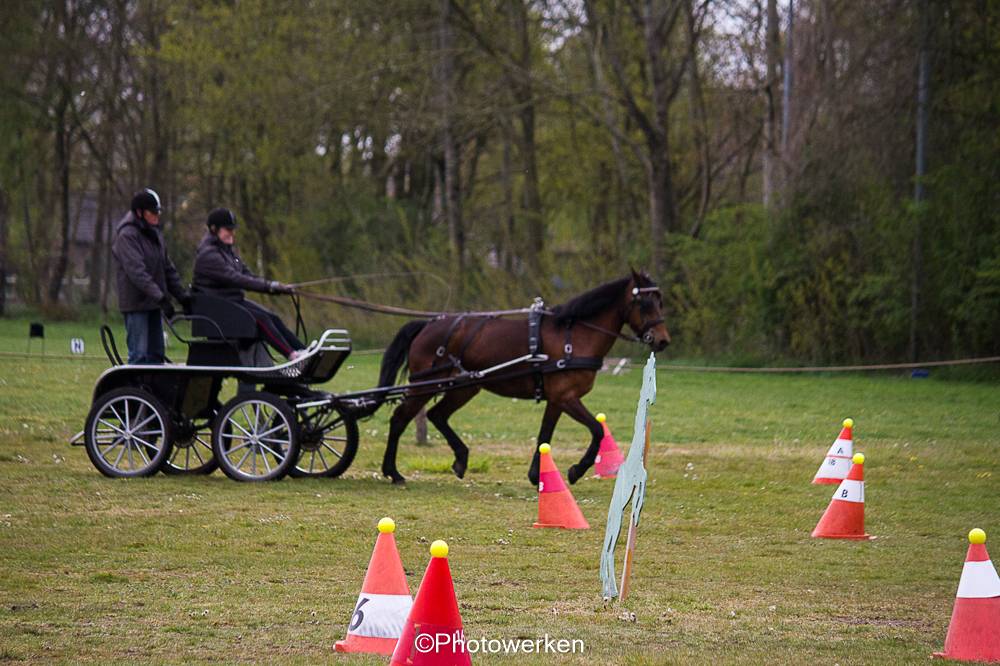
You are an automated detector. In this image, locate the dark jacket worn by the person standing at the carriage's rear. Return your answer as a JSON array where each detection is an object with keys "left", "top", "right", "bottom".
[{"left": 111, "top": 215, "right": 185, "bottom": 312}]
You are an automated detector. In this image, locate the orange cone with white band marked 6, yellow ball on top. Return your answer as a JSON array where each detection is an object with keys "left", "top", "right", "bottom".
[{"left": 334, "top": 518, "right": 413, "bottom": 655}]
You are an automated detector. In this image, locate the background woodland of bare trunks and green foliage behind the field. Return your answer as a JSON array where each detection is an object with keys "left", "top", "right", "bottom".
[{"left": 0, "top": 0, "right": 1000, "bottom": 362}]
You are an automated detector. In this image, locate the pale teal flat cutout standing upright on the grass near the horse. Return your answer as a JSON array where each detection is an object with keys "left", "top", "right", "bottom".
[{"left": 601, "top": 354, "right": 656, "bottom": 599}]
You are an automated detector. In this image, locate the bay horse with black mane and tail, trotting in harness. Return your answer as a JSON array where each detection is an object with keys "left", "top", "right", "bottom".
[{"left": 376, "top": 270, "right": 670, "bottom": 485}]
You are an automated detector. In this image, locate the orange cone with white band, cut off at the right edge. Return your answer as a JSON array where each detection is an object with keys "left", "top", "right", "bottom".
[{"left": 934, "top": 528, "right": 1000, "bottom": 662}]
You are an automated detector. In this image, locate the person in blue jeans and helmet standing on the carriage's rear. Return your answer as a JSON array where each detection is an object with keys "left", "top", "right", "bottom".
[{"left": 111, "top": 187, "right": 191, "bottom": 364}]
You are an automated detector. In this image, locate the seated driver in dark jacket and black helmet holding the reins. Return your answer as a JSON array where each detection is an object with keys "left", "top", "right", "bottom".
[{"left": 193, "top": 208, "right": 305, "bottom": 361}]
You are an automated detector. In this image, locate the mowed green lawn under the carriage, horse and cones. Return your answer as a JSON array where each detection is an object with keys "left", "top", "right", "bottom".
[{"left": 0, "top": 322, "right": 1000, "bottom": 664}]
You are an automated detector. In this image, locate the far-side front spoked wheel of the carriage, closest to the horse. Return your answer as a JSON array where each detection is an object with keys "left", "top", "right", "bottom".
[{"left": 289, "top": 408, "right": 358, "bottom": 478}]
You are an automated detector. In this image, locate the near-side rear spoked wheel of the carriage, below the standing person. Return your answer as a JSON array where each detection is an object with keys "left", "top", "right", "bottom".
[{"left": 84, "top": 388, "right": 173, "bottom": 478}]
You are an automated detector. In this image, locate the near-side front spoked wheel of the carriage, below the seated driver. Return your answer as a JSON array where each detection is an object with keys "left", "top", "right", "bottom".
[{"left": 212, "top": 391, "right": 299, "bottom": 481}]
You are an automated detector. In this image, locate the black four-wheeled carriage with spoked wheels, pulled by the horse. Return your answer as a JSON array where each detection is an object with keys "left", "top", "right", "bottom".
[{"left": 74, "top": 294, "right": 358, "bottom": 481}]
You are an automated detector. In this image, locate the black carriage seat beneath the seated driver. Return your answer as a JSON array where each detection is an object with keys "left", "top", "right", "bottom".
[{"left": 187, "top": 291, "right": 274, "bottom": 367}]
